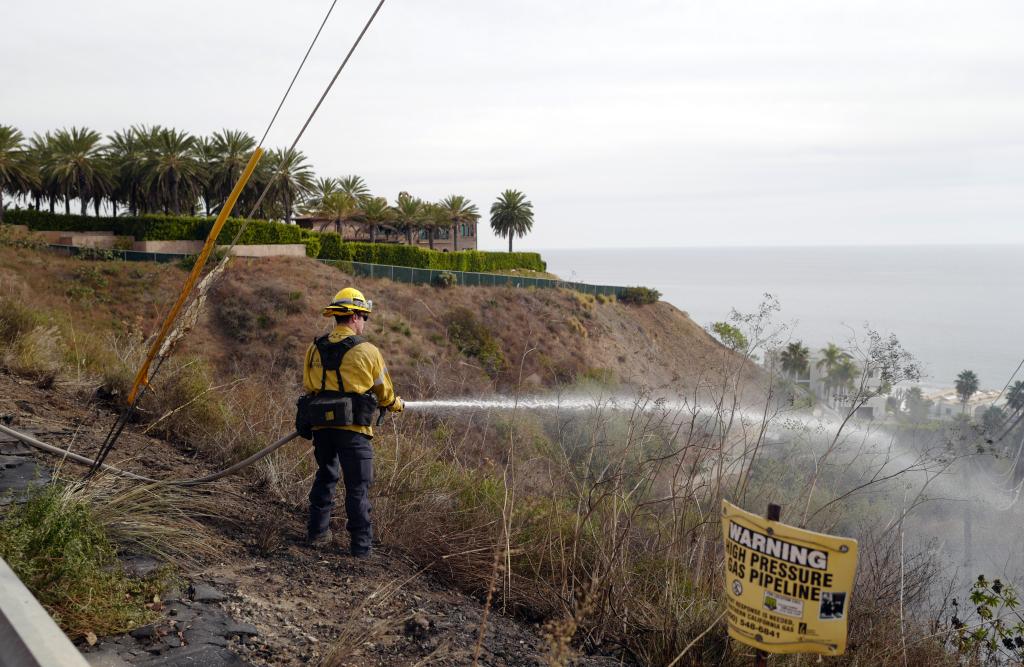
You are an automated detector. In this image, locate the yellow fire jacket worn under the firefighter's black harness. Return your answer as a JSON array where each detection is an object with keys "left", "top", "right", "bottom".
[{"left": 302, "top": 325, "right": 395, "bottom": 437}]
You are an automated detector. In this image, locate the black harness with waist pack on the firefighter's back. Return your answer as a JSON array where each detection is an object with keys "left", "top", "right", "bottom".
[{"left": 295, "top": 334, "right": 378, "bottom": 437}]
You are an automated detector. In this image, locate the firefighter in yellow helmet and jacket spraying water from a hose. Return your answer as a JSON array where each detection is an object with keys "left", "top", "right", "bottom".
[{"left": 296, "top": 287, "right": 404, "bottom": 558}]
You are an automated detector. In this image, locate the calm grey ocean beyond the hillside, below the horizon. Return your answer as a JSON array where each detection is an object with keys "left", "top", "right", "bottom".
[{"left": 542, "top": 245, "right": 1024, "bottom": 389}]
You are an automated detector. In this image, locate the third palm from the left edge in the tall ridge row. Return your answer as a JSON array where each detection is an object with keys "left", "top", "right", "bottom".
[{"left": 46, "top": 127, "right": 103, "bottom": 215}]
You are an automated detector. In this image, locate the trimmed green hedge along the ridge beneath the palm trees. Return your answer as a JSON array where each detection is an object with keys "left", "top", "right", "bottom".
[{"left": 4, "top": 209, "right": 547, "bottom": 273}]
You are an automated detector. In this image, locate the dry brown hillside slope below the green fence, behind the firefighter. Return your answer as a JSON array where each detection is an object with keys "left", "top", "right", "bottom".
[{"left": 0, "top": 248, "right": 756, "bottom": 399}]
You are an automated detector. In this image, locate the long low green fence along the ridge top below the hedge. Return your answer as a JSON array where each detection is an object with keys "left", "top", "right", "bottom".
[{"left": 49, "top": 243, "right": 627, "bottom": 297}]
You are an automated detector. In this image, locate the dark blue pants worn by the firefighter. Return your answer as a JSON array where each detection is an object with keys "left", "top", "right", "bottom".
[{"left": 308, "top": 428, "right": 374, "bottom": 553}]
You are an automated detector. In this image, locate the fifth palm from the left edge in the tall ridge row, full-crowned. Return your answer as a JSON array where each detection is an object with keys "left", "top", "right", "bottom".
[{"left": 146, "top": 128, "right": 206, "bottom": 214}]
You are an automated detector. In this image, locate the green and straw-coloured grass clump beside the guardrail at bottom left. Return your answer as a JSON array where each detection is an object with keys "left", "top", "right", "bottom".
[{"left": 0, "top": 467, "right": 219, "bottom": 638}]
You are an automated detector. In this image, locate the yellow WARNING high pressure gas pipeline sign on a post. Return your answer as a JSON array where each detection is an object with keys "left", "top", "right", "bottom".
[{"left": 722, "top": 500, "right": 857, "bottom": 656}]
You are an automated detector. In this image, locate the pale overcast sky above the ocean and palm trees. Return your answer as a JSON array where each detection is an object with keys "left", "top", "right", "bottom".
[{"left": 0, "top": 0, "right": 1024, "bottom": 249}]
